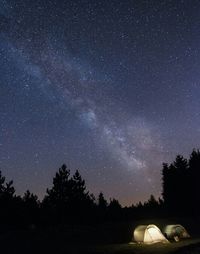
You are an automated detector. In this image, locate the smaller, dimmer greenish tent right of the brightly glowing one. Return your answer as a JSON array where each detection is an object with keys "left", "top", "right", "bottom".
[{"left": 163, "top": 224, "right": 190, "bottom": 239}]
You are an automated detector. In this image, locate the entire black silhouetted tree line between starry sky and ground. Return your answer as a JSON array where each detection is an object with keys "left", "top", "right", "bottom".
[{"left": 0, "top": 150, "right": 200, "bottom": 228}]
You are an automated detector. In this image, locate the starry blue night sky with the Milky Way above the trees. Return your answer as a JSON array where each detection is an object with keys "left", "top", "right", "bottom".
[{"left": 0, "top": 0, "right": 200, "bottom": 205}]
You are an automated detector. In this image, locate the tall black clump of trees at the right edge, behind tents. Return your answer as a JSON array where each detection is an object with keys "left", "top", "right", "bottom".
[{"left": 162, "top": 150, "right": 200, "bottom": 215}]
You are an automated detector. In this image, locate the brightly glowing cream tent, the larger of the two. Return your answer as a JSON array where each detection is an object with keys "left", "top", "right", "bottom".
[{"left": 133, "top": 224, "right": 168, "bottom": 244}]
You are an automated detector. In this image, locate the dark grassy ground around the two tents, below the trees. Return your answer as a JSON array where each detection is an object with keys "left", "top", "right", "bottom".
[{"left": 0, "top": 219, "right": 200, "bottom": 254}]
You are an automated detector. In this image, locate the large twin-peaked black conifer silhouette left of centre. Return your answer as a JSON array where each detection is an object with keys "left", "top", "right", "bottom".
[{"left": 43, "top": 164, "right": 94, "bottom": 221}]
